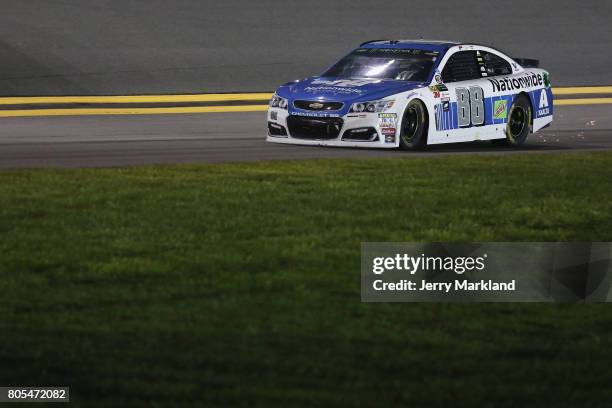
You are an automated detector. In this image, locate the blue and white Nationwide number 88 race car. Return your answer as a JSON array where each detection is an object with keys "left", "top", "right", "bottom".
[{"left": 267, "top": 40, "right": 553, "bottom": 149}]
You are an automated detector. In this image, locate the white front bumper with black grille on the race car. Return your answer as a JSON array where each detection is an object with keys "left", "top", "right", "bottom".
[{"left": 266, "top": 108, "right": 398, "bottom": 148}]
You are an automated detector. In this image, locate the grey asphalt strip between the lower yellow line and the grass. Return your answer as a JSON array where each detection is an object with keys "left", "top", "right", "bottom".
[{"left": 0, "top": 105, "right": 612, "bottom": 168}]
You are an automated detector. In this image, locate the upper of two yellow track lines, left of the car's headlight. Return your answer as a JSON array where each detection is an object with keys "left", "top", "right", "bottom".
[{"left": 0, "top": 92, "right": 272, "bottom": 105}]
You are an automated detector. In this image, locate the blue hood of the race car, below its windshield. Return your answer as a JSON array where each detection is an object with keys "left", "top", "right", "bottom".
[{"left": 277, "top": 77, "right": 427, "bottom": 102}]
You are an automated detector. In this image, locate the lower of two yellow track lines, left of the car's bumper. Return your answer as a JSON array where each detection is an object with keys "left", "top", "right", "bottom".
[{"left": 0, "top": 105, "right": 268, "bottom": 117}]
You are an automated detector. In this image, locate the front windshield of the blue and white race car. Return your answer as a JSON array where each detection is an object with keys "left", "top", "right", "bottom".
[{"left": 322, "top": 48, "right": 438, "bottom": 82}]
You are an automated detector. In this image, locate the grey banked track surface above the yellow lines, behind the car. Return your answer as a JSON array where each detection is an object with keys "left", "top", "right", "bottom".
[{"left": 0, "top": 0, "right": 612, "bottom": 95}]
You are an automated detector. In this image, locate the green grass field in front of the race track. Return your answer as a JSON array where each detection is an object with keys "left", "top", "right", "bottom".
[{"left": 0, "top": 153, "right": 612, "bottom": 407}]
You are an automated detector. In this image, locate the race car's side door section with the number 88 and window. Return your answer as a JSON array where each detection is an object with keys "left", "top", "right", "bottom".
[{"left": 435, "top": 49, "right": 495, "bottom": 142}]
